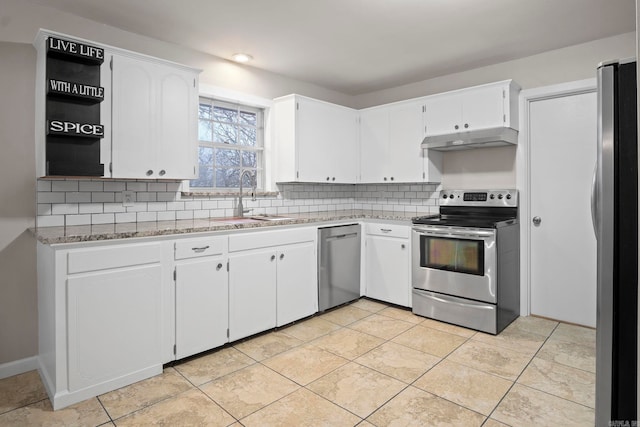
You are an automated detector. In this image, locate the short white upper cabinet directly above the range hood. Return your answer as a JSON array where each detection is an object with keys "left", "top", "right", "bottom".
[{"left": 425, "top": 80, "right": 520, "bottom": 136}]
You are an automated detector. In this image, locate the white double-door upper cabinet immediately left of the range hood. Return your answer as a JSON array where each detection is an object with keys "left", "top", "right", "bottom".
[{"left": 360, "top": 99, "right": 442, "bottom": 183}]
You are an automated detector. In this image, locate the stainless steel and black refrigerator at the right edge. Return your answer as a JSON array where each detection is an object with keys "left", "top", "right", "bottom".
[{"left": 592, "top": 60, "right": 638, "bottom": 427}]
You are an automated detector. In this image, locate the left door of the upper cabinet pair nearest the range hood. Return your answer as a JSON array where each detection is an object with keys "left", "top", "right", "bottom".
[{"left": 360, "top": 107, "right": 389, "bottom": 183}]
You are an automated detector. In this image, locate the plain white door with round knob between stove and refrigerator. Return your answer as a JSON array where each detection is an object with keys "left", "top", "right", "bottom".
[{"left": 522, "top": 92, "right": 597, "bottom": 327}]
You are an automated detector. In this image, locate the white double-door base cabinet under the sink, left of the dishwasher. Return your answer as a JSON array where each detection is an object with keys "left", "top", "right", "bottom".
[{"left": 229, "top": 228, "right": 318, "bottom": 341}]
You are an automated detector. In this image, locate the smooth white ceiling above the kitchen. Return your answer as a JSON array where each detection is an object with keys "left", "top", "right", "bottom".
[{"left": 29, "top": 0, "right": 635, "bottom": 95}]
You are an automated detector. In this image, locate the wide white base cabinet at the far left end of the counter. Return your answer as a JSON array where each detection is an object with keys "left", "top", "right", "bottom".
[{"left": 38, "top": 242, "right": 172, "bottom": 409}]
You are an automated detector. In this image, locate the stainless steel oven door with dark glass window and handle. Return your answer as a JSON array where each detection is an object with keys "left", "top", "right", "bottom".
[{"left": 411, "top": 225, "right": 497, "bottom": 304}]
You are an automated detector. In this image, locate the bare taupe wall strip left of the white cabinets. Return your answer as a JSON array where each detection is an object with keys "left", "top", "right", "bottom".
[{"left": 0, "top": 42, "right": 38, "bottom": 364}]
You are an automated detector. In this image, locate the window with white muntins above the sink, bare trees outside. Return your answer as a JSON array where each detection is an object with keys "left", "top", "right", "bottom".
[{"left": 190, "top": 98, "right": 264, "bottom": 189}]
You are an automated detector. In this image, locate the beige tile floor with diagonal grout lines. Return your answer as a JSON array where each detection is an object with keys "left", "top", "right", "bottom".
[{"left": 0, "top": 298, "right": 595, "bottom": 427}]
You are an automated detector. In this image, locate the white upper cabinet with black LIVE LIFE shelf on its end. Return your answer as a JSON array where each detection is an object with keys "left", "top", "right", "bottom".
[{"left": 34, "top": 30, "right": 200, "bottom": 180}]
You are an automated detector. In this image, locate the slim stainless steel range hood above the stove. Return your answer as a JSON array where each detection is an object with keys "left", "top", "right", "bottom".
[{"left": 421, "top": 127, "right": 518, "bottom": 151}]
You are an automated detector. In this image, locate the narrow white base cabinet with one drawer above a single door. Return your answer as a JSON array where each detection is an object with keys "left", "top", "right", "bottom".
[{"left": 174, "top": 236, "right": 229, "bottom": 359}]
